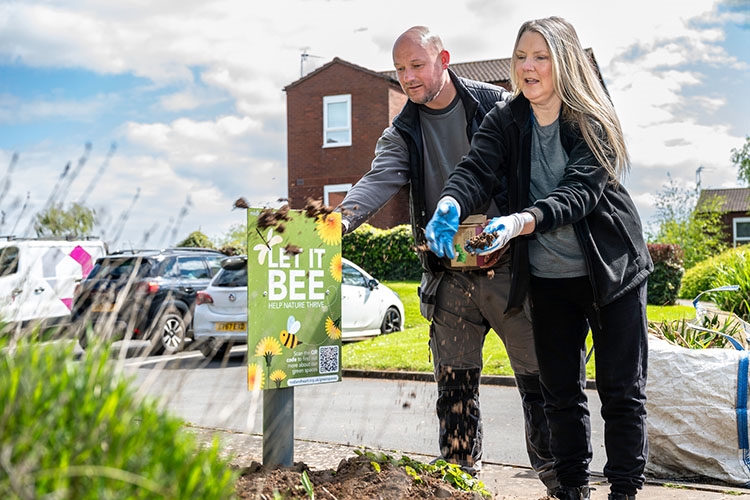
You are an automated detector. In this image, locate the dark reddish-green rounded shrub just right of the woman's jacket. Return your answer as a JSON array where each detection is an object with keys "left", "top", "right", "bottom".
[{"left": 648, "top": 243, "right": 685, "bottom": 306}]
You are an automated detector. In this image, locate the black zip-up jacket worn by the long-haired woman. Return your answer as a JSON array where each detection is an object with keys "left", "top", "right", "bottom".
[{"left": 442, "top": 94, "right": 654, "bottom": 308}]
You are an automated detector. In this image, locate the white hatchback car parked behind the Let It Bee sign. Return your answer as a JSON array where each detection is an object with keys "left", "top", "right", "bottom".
[{"left": 193, "top": 255, "right": 404, "bottom": 358}]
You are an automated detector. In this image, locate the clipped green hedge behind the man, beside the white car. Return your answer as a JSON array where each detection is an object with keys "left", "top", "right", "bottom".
[{"left": 341, "top": 224, "right": 422, "bottom": 281}]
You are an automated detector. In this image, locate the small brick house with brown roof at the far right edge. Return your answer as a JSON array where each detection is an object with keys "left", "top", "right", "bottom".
[{"left": 695, "top": 188, "right": 750, "bottom": 247}]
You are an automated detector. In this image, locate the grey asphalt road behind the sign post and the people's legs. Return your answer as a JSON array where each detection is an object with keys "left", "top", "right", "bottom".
[{"left": 123, "top": 348, "right": 605, "bottom": 472}]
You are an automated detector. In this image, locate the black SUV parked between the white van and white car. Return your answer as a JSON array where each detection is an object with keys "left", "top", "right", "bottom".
[{"left": 71, "top": 247, "right": 226, "bottom": 354}]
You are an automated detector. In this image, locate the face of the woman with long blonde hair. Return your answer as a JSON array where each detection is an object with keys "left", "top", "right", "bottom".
[{"left": 513, "top": 31, "right": 561, "bottom": 110}]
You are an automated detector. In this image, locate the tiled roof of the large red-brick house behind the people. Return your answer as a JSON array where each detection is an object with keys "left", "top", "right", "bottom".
[{"left": 284, "top": 48, "right": 604, "bottom": 91}]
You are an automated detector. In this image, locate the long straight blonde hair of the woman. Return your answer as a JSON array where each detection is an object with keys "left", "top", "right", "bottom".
[{"left": 510, "top": 17, "right": 630, "bottom": 183}]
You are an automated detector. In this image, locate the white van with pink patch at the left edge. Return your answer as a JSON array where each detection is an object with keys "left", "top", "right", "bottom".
[{"left": 0, "top": 236, "right": 107, "bottom": 326}]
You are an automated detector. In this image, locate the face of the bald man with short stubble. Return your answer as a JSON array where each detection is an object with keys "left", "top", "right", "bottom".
[{"left": 393, "top": 39, "right": 447, "bottom": 104}]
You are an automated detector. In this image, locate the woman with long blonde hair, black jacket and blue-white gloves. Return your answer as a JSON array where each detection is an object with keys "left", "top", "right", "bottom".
[{"left": 426, "top": 17, "right": 653, "bottom": 500}]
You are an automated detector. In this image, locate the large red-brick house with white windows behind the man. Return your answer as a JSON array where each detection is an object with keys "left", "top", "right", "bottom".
[{"left": 284, "top": 49, "right": 601, "bottom": 228}]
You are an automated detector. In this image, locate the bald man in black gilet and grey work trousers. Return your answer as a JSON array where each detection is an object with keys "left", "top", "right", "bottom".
[{"left": 339, "top": 26, "right": 558, "bottom": 490}]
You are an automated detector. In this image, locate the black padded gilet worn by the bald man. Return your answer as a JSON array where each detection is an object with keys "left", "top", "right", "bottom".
[{"left": 393, "top": 68, "right": 510, "bottom": 271}]
